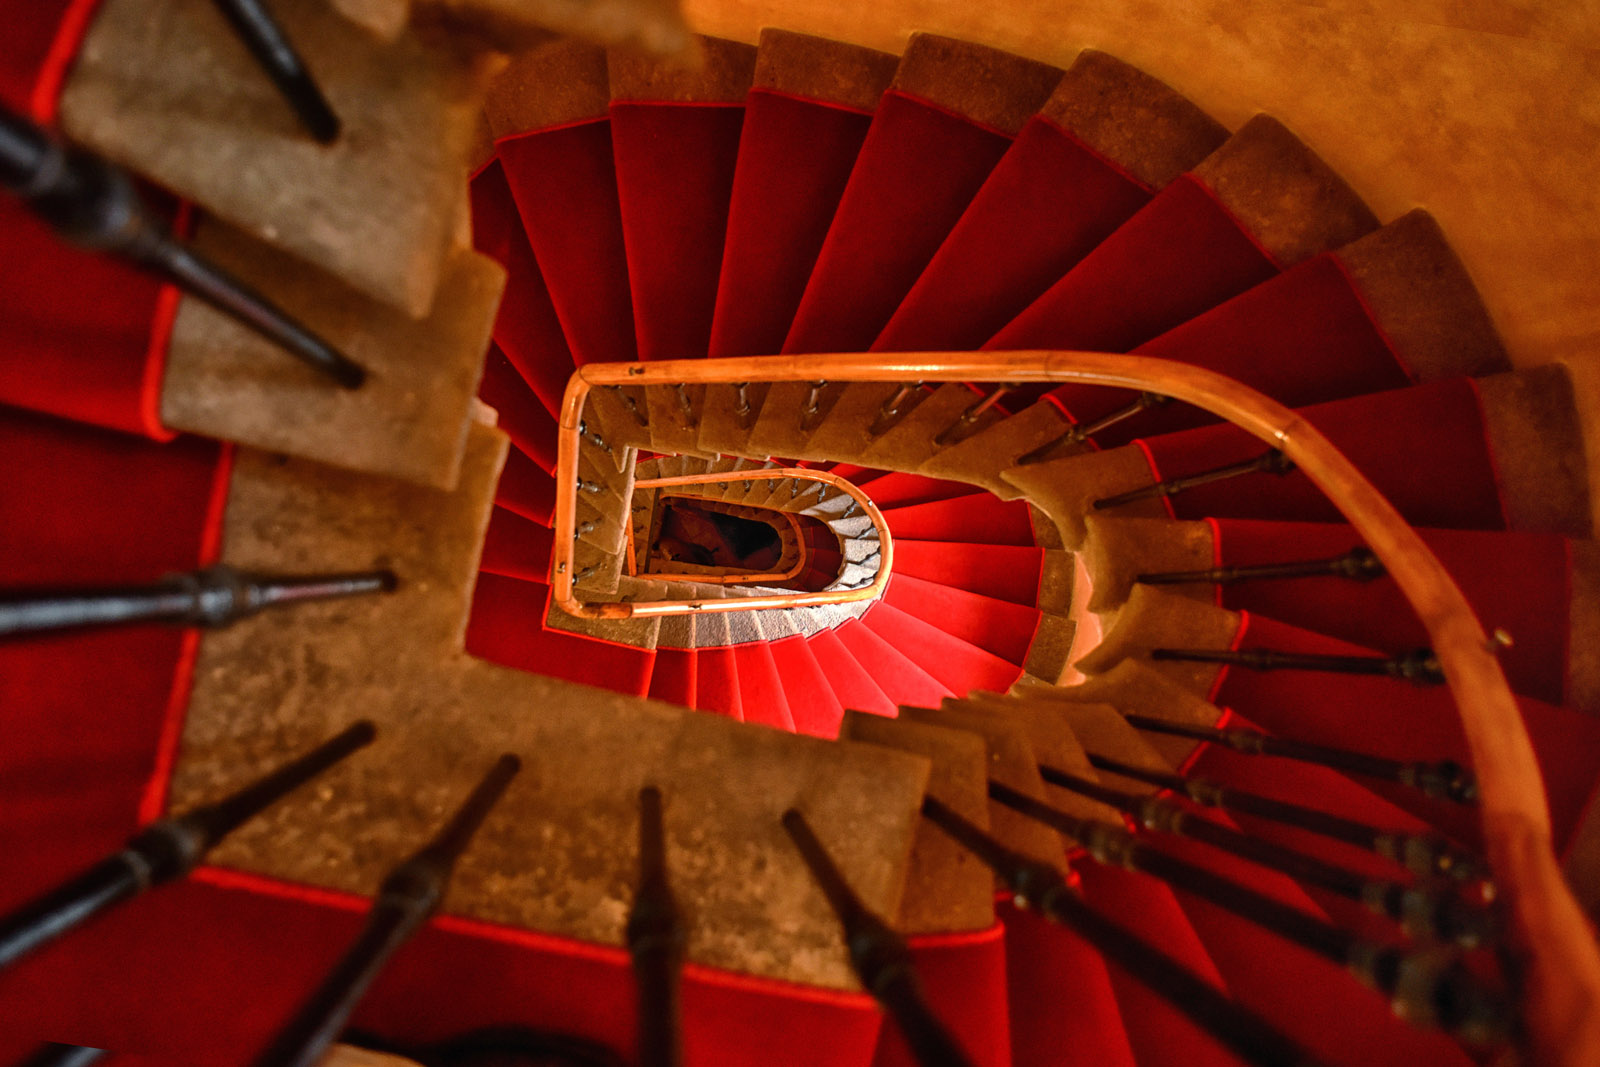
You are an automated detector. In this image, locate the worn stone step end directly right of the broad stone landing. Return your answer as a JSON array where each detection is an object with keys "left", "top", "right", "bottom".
[{"left": 838, "top": 712, "right": 995, "bottom": 934}]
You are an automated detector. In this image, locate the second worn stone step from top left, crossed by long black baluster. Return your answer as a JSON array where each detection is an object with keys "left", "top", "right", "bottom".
[{"left": 162, "top": 222, "right": 506, "bottom": 488}]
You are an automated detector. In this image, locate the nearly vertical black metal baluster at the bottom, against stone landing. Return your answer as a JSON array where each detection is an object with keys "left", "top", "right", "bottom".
[{"left": 627, "top": 785, "right": 686, "bottom": 1067}]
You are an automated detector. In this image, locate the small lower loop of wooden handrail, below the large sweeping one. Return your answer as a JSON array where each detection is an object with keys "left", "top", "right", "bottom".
[{"left": 552, "top": 463, "right": 894, "bottom": 619}]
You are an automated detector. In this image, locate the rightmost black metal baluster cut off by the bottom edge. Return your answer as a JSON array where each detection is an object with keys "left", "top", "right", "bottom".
[{"left": 922, "top": 797, "right": 1320, "bottom": 1067}]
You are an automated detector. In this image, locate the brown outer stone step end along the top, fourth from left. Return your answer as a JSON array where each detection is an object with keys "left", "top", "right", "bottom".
[{"left": 893, "top": 34, "right": 1061, "bottom": 136}]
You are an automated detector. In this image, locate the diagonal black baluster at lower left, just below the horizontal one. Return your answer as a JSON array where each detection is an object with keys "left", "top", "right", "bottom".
[{"left": 0, "top": 721, "right": 378, "bottom": 969}]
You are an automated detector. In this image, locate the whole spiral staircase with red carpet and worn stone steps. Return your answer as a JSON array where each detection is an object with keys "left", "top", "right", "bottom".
[{"left": 0, "top": 0, "right": 1600, "bottom": 1067}]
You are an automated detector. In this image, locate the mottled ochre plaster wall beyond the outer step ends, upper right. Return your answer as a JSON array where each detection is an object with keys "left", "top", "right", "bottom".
[{"left": 685, "top": 0, "right": 1600, "bottom": 521}]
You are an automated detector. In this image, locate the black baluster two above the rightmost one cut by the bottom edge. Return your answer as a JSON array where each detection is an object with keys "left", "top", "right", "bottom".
[{"left": 1038, "top": 765, "right": 1498, "bottom": 949}]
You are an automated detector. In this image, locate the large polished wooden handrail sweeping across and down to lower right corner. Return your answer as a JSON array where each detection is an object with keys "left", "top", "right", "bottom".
[{"left": 554, "top": 350, "right": 1600, "bottom": 1067}]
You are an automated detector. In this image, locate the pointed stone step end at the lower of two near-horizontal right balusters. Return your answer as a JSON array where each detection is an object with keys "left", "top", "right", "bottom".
[{"left": 1074, "top": 585, "right": 1240, "bottom": 693}]
